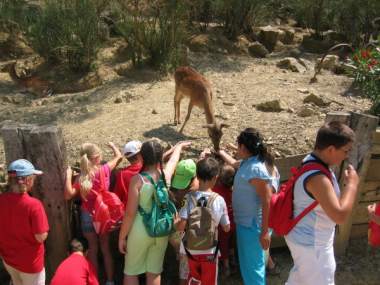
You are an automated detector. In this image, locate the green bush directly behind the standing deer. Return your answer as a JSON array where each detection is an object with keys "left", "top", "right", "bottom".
[{"left": 116, "top": 0, "right": 186, "bottom": 72}]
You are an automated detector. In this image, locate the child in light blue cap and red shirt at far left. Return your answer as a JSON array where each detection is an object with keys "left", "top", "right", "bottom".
[{"left": 0, "top": 159, "right": 49, "bottom": 285}]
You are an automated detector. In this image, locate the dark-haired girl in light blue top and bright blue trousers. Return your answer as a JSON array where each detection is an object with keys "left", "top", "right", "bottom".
[{"left": 219, "top": 128, "right": 278, "bottom": 285}]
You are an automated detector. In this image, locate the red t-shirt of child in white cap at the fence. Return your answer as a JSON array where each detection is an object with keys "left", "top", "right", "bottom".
[{"left": 114, "top": 163, "right": 142, "bottom": 205}]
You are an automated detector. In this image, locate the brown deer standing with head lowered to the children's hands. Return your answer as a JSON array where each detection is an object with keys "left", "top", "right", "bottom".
[{"left": 174, "top": 66, "right": 228, "bottom": 150}]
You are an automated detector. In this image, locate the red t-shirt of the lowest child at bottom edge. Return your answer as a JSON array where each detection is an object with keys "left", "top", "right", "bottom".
[{"left": 50, "top": 253, "right": 99, "bottom": 285}]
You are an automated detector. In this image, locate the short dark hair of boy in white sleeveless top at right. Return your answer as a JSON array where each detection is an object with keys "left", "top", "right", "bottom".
[{"left": 314, "top": 121, "right": 355, "bottom": 150}]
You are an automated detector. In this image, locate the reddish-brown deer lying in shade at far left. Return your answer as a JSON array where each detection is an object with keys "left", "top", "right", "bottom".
[{"left": 7, "top": 62, "right": 53, "bottom": 97}]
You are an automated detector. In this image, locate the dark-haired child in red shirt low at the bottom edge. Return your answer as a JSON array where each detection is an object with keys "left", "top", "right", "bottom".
[{"left": 50, "top": 239, "right": 99, "bottom": 285}]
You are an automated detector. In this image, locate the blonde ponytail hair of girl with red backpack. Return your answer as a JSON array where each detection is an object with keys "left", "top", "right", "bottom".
[{"left": 79, "top": 143, "right": 101, "bottom": 199}]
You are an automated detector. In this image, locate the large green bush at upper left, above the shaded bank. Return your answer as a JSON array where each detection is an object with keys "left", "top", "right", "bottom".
[{"left": 27, "top": 0, "right": 101, "bottom": 71}]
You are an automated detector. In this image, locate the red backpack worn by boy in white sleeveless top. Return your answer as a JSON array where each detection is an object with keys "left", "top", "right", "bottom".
[{"left": 269, "top": 161, "right": 332, "bottom": 236}]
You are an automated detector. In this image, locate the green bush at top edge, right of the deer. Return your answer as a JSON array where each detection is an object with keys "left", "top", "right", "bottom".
[{"left": 214, "top": 0, "right": 269, "bottom": 39}]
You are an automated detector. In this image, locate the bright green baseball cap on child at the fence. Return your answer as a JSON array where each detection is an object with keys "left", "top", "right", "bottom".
[{"left": 172, "top": 159, "right": 197, "bottom": 189}]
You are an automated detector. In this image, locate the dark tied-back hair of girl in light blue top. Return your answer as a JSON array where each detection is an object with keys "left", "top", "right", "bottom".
[{"left": 237, "top": 128, "right": 274, "bottom": 172}]
